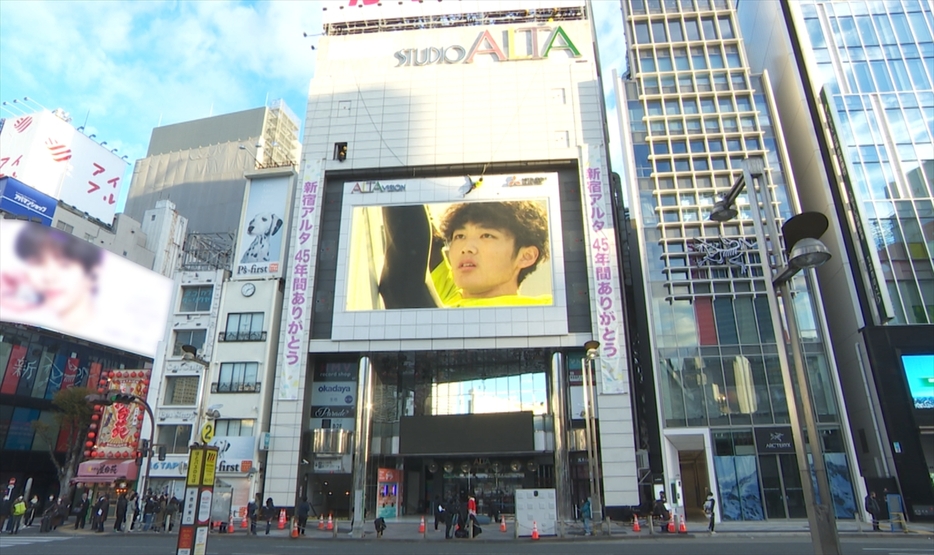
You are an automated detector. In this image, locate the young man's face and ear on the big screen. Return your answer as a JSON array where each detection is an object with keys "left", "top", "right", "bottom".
[{"left": 448, "top": 222, "right": 538, "bottom": 299}]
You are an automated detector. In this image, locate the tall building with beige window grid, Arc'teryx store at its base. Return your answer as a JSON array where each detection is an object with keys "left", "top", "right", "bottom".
[{"left": 618, "top": 0, "right": 857, "bottom": 520}]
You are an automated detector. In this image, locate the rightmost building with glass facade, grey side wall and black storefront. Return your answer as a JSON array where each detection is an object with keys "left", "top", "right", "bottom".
[{"left": 738, "top": 0, "right": 934, "bottom": 518}]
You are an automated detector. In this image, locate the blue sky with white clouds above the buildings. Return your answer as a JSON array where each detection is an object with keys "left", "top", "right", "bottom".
[{"left": 0, "top": 0, "right": 625, "bottom": 209}]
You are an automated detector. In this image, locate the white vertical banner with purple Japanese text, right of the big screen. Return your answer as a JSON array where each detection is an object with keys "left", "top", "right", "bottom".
[{"left": 583, "top": 145, "right": 629, "bottom": 395}]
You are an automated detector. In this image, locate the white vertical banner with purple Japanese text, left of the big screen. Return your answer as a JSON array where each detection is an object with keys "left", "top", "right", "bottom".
[{"left": 279, "top": 160, "right": 324, "bottom": 401}]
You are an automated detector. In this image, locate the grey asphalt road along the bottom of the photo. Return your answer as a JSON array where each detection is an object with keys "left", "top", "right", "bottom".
[{"left": 0, "top": 532, "right": 934, "bottom": 555}]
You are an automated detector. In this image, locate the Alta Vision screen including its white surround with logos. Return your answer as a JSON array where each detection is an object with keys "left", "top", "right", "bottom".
[{"left": 334, "top": 173, "right": 567, "bottom": 339}]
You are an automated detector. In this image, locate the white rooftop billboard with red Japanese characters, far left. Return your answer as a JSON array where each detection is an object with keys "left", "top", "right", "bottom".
[{"left": 0, "top": 111, "right": 128, "bottom": 224}]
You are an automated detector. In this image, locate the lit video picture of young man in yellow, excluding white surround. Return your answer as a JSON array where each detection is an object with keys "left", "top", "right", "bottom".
[{"left": 347, "top": 199, "right": 554, "bottom": 310}]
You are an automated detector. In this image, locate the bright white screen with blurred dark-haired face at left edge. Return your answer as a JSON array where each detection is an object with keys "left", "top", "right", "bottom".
[{"left": 0, "top": 220, "right": 172, "bottom": 357}]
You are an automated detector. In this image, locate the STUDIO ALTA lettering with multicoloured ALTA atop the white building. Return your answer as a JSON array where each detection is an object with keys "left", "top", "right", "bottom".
[{"left": 394, "top": 26, "right": 581, "bottom": 67}]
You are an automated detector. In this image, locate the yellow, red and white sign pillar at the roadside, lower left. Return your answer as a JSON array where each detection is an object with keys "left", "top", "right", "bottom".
[{"left": 176, "top": 446, "right": 217, "bottom": 555}]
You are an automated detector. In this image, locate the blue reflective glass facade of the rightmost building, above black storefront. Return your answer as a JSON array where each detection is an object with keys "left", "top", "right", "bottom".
[{"left": 800, "top": 0, "right": 934, "bottom": 324}]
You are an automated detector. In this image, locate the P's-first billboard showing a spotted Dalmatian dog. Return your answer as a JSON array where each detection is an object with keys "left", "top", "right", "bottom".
[{"left": 233, "top": 175, "right": 291, "bottom": 279}]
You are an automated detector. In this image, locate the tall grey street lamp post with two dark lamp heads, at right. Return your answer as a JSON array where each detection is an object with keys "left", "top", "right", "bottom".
[{"left": 710, "top": 159, "right": 840, "bottom": 555}]
